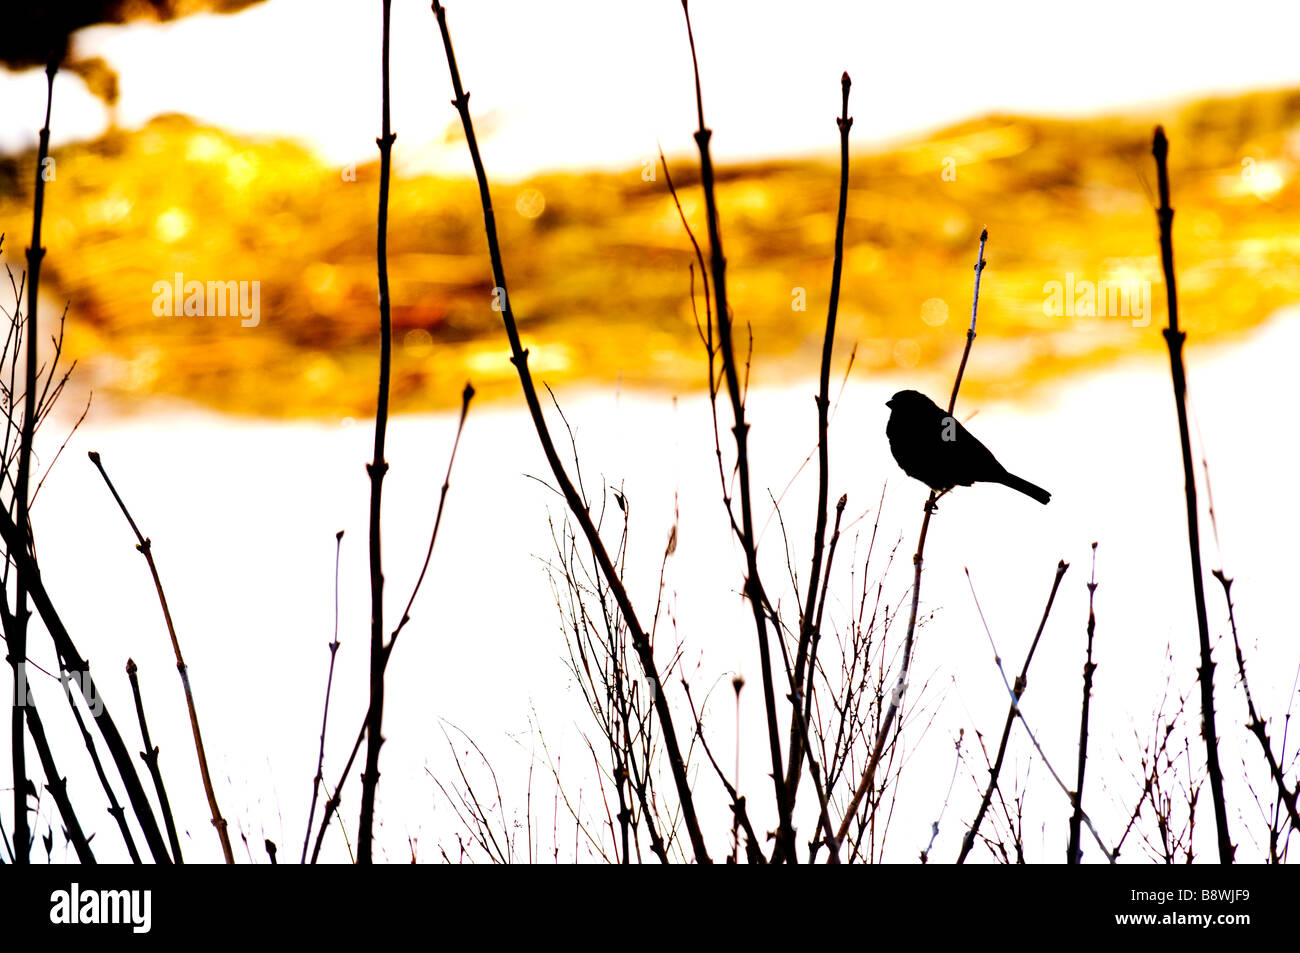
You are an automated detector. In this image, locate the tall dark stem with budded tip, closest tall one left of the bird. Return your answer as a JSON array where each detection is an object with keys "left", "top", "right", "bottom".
[{"left": 785, "top": 73, "right": 853, "bottom": 800}]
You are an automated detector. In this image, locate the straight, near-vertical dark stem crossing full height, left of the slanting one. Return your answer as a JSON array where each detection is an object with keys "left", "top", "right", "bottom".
[{"left": 356, "top": 0, "right": 397, "bottom": 863}]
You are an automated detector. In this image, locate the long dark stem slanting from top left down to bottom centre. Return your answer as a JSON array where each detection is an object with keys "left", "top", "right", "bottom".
[{"left": 433, "top": 0, "right": 710, "bottom": 863}]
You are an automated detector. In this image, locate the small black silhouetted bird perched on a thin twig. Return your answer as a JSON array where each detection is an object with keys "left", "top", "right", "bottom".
[{"left": 885, "top": 390, "right": 1052, "bottom": 504}]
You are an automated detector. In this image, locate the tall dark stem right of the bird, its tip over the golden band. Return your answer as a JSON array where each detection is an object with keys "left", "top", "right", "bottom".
[{"left": 1151, "top": 126, "right": 1235, "bottom": 863}]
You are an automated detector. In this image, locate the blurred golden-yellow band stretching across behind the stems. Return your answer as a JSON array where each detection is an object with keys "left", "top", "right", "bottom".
[{"left": 0, "top": 90, "right": 1300, "bottom": 419}]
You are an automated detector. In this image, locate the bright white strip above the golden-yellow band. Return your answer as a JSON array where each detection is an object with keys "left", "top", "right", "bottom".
[{"left": 0, "top": 0, "right": 1300, "bottom": 177}]
